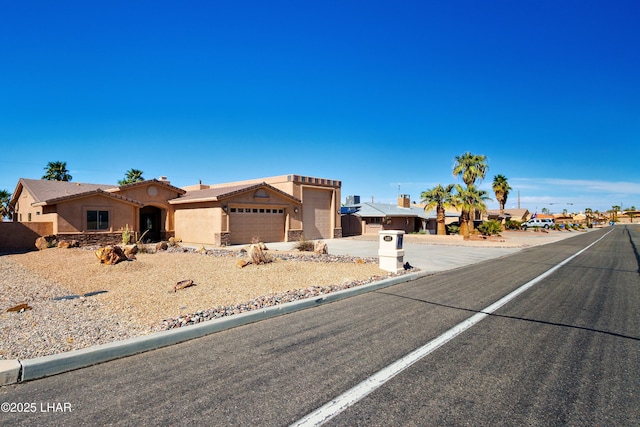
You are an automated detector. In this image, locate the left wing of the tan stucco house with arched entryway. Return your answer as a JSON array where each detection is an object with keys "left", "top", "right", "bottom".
[{"left": 9, "top": 178, "right": 186, "bottom": 243}]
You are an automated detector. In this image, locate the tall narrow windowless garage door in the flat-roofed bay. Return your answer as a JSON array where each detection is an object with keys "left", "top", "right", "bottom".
[{"left": 302, "top": 188, "right": 332, "bottom": 239}]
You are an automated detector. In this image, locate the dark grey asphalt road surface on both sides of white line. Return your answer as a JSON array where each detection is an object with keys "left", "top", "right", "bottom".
[{"left": 0, "top": 225, "right": 640, "bottom": 426}]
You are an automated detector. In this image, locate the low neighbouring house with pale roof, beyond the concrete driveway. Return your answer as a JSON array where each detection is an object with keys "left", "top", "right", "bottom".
[{"left": 342, "top": 195, "right": 460, "bottom": 236}]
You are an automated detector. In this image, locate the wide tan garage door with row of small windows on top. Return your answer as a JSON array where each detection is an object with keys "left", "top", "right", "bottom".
[{"left": 229, "top": 206, "right": 285, "bottom": 245}]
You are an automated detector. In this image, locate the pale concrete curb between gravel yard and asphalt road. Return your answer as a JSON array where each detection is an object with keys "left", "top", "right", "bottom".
[{"left": 0, "top": 271, "right": 433, "bottom": 386}]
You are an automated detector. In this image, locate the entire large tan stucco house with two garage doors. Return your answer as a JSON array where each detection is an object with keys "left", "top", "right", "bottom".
[{"left": 10, "top": 175, "right": 342, "bottom": 246}]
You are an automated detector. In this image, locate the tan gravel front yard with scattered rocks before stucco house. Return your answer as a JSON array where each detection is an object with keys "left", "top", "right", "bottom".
[{"left": 0, "top": 249, "right": 388, "bottom": 359}]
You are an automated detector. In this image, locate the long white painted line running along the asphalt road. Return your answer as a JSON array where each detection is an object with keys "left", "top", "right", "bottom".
[{"left": 291, "top": 230, "right": 613, "bottom": 427}]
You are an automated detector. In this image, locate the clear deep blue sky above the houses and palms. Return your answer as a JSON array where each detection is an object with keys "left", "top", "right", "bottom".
[{"left": 0, "top": 0, "right": 640, "bottom": 212}]
